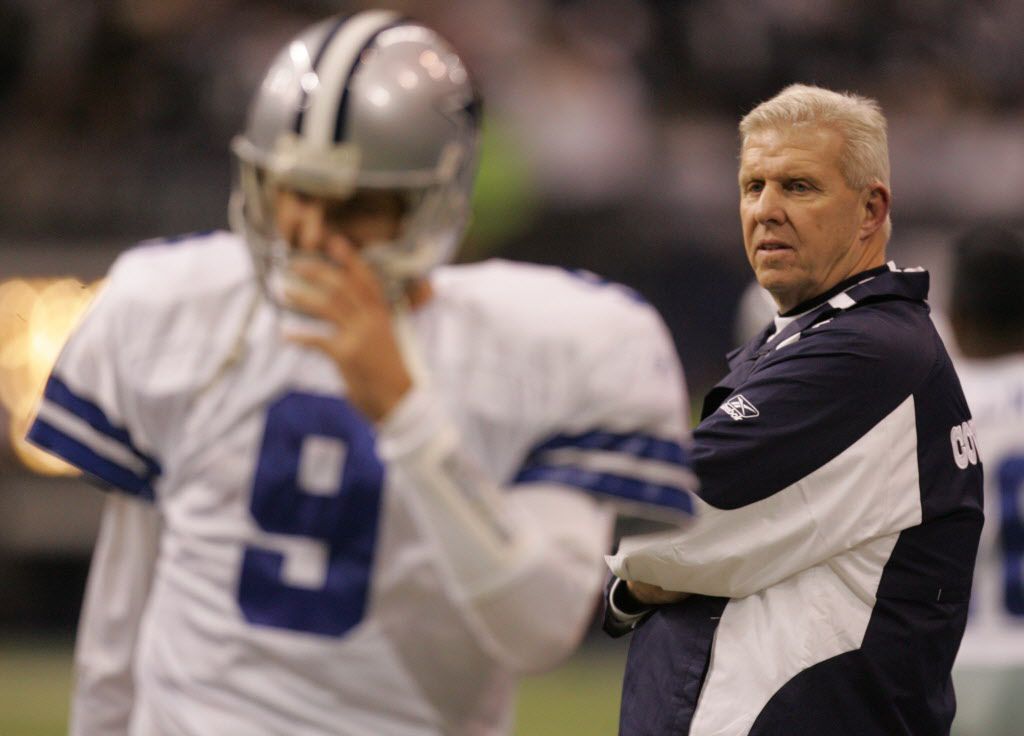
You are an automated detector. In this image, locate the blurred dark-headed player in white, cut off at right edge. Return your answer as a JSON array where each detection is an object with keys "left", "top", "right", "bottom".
[{"left": 949, "top": 225, "right": 1024, "bottom": 736}]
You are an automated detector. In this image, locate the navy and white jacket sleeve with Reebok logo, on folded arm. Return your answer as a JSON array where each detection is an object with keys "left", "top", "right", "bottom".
[{"left": 608, "top": 329, "right": 934, "bottom": 598}]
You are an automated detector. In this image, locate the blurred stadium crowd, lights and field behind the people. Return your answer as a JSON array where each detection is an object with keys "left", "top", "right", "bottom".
[{"left": 0, "top": 0, "right": 1024, "bottom": 736}]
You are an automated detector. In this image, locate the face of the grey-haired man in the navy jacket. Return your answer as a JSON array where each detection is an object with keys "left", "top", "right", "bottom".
[{"left": 739, "top": 126, "right": 873, "bottom": 312}]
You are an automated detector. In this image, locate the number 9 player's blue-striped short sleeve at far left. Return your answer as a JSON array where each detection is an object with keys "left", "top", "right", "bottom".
[{"left": 28, "top": 258, "right": 161, "bottom": 500}]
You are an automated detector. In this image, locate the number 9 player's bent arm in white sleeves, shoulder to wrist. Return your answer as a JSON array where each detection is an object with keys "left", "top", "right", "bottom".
[{"left": 378, "top": 298, "right": 690, "bottom": 672}]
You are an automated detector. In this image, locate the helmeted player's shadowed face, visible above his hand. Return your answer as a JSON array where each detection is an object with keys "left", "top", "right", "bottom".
[{"left": 274, "top": 188, "right": 406, "bottom": 255}]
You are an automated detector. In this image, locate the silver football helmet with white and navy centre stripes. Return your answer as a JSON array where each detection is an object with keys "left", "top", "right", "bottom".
[{"left": 229, "top": 10, "right": 480, "bottom": 304}]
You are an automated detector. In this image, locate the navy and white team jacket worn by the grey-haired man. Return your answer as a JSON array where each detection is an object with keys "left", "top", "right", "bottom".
[{"left": 608, "top": 265, "right": 982, "bottom": 736}]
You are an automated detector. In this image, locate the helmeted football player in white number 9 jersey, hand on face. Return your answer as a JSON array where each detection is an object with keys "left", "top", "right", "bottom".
[{"left": 30, "top": 11, "right": 692, "bottom": 736}]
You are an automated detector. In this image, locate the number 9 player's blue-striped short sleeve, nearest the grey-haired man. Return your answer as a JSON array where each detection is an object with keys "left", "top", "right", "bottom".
[{"left": 513, "top": 305, "right": 696, "bottom": 524}]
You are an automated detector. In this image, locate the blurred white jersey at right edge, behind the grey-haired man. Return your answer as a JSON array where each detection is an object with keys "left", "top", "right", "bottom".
[{"left": 956, "top": 353, "right": 1024, "bottom": 666}]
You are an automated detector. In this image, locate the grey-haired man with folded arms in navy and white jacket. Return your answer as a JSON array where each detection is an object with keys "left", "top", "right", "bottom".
[{"left": 606, "top": 85, "right": 982, "bottom": 736}]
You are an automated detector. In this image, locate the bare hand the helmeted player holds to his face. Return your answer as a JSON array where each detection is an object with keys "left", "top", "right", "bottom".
[{"left": 287, "top": 233, "right": 413, "bottom": 422}]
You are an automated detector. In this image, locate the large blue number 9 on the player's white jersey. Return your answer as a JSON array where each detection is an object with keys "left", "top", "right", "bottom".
[{"left": 239, "top": 393, "right": 384, "bottom": 637}]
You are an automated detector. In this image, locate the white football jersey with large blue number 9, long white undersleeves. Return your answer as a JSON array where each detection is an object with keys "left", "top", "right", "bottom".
[{"left": 30, "top": 232, "right": 691, "bottom": 736}]
